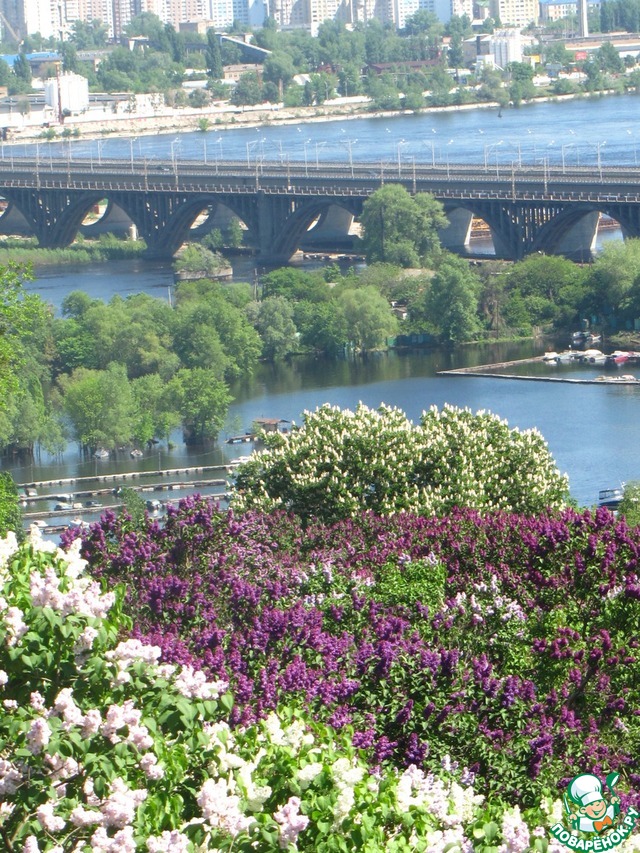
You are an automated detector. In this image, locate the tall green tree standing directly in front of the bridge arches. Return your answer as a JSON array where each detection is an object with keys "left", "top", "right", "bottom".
[{"left": 362, "top": 184, "right": 448, "bottom": 267}]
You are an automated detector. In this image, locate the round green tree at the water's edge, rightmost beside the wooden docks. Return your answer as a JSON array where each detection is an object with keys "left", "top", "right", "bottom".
[{"left": 168, "top": 368, "right": 233, "bottom": 444}]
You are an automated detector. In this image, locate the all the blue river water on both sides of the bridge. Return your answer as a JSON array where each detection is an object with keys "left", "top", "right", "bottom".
[{"left": 4, "top": 96, "right": 640, "bottom": 505}]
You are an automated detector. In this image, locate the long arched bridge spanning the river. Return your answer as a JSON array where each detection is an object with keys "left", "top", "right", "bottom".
[{"left": 0, "top": 156, "right": 640, "bottom": 264}]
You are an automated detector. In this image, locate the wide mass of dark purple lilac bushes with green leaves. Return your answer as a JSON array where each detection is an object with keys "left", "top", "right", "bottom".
[{"left": 72, "top": 497, "right": 640, "bottom": 808}]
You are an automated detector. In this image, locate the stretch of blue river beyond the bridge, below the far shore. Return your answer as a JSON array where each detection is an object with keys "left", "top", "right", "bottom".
[{"left": 15, "top": 95, "right": 640, "bottom": 170}]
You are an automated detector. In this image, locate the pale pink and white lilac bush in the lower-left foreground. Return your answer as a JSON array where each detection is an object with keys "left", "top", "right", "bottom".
[{"left": 0, "top": 534, "right": 516, "bottom": 853}]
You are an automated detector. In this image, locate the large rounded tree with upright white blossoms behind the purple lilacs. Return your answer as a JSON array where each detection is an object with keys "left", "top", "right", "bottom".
[{"left": 232, "top": 404, "right": 568, "bottom": 521}]
